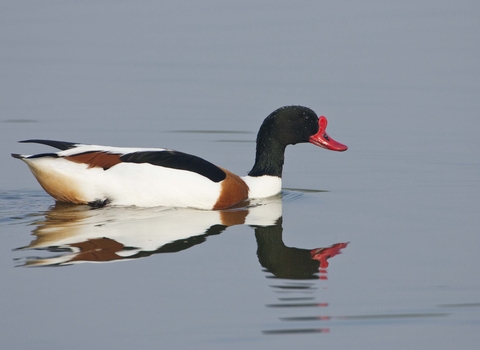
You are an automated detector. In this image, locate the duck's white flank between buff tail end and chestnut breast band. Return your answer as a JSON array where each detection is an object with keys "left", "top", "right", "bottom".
[{"left": 23, "top": 155, "right": 221, "bottom": 209}]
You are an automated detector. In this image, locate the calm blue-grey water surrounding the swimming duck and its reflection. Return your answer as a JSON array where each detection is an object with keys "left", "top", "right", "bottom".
[{"left": 0, "top": 0, "right": 480, "bottom": 349}]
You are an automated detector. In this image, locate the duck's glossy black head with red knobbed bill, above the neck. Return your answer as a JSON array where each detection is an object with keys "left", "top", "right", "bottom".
[{"left": 257, "top": 106, "right": 348, "bottom": 152}]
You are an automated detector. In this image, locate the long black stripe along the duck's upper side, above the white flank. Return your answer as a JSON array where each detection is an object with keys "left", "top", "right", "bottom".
[{"left": 120, "top": 150, "right": 227, "bottom": 182}]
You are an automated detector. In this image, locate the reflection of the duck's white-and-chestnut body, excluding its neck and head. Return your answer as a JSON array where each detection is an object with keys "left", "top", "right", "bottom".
[{"left": 15, "top": 203, "right": 255, "bottom": 266}]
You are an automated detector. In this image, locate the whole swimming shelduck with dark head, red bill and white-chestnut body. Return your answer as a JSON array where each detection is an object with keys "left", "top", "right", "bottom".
[{"left": 12, "top": 106, "right": 347, "bottom": 210}]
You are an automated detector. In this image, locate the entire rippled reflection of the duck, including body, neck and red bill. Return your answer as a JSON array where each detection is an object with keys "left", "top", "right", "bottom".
[{"left": 15, "top": 196, "right": 348, "bottom": 334}]
